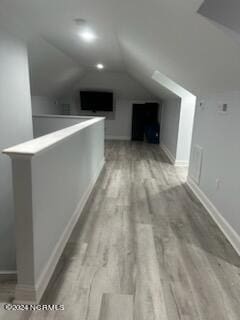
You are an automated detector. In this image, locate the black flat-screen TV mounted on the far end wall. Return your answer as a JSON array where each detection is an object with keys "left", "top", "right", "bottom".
[{"left": 80, "top": 91, "right": 113, "bottom": 112}]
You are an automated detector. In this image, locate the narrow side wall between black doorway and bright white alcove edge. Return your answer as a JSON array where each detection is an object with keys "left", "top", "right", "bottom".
[{"left": 160, "top": 98, "right": 181, "bottom": 161}]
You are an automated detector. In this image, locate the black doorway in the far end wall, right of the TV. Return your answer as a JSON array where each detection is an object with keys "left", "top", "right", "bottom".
[{"left": 132, "top": 103, "right": 159, "bottom": 143}]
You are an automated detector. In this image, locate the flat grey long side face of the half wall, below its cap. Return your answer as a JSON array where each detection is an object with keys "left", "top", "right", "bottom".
[{"left": 32, "top": 122, "right": 104, "bottom": 286}]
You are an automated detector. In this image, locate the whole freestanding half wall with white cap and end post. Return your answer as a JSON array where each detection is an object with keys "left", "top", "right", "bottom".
[{"left": 5, "top": 118, "right": 105, "bottom": 303}]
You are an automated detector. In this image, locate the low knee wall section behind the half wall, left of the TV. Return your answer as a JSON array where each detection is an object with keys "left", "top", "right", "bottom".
[{"left": 32, "top": 96, "right": 62, "bottom": 115}]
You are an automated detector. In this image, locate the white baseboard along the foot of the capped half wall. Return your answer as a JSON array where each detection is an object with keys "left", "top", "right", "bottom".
[{"left": 14, "top": 159, "right": 105, "bottom": 303}]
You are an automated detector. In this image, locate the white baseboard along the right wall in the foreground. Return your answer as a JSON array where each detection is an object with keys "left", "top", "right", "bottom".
[{"left": 187, "top": 176, "right": 240, "bottom": 256}]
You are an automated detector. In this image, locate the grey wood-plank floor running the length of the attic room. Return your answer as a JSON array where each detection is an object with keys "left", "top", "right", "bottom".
[{"left": 0, "top": 141, "right": 240, "bottom": 320}]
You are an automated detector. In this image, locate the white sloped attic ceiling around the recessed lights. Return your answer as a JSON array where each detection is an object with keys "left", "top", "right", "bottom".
[{"left": 0, "top": 0, "right": 240, "bottom": 98}]
